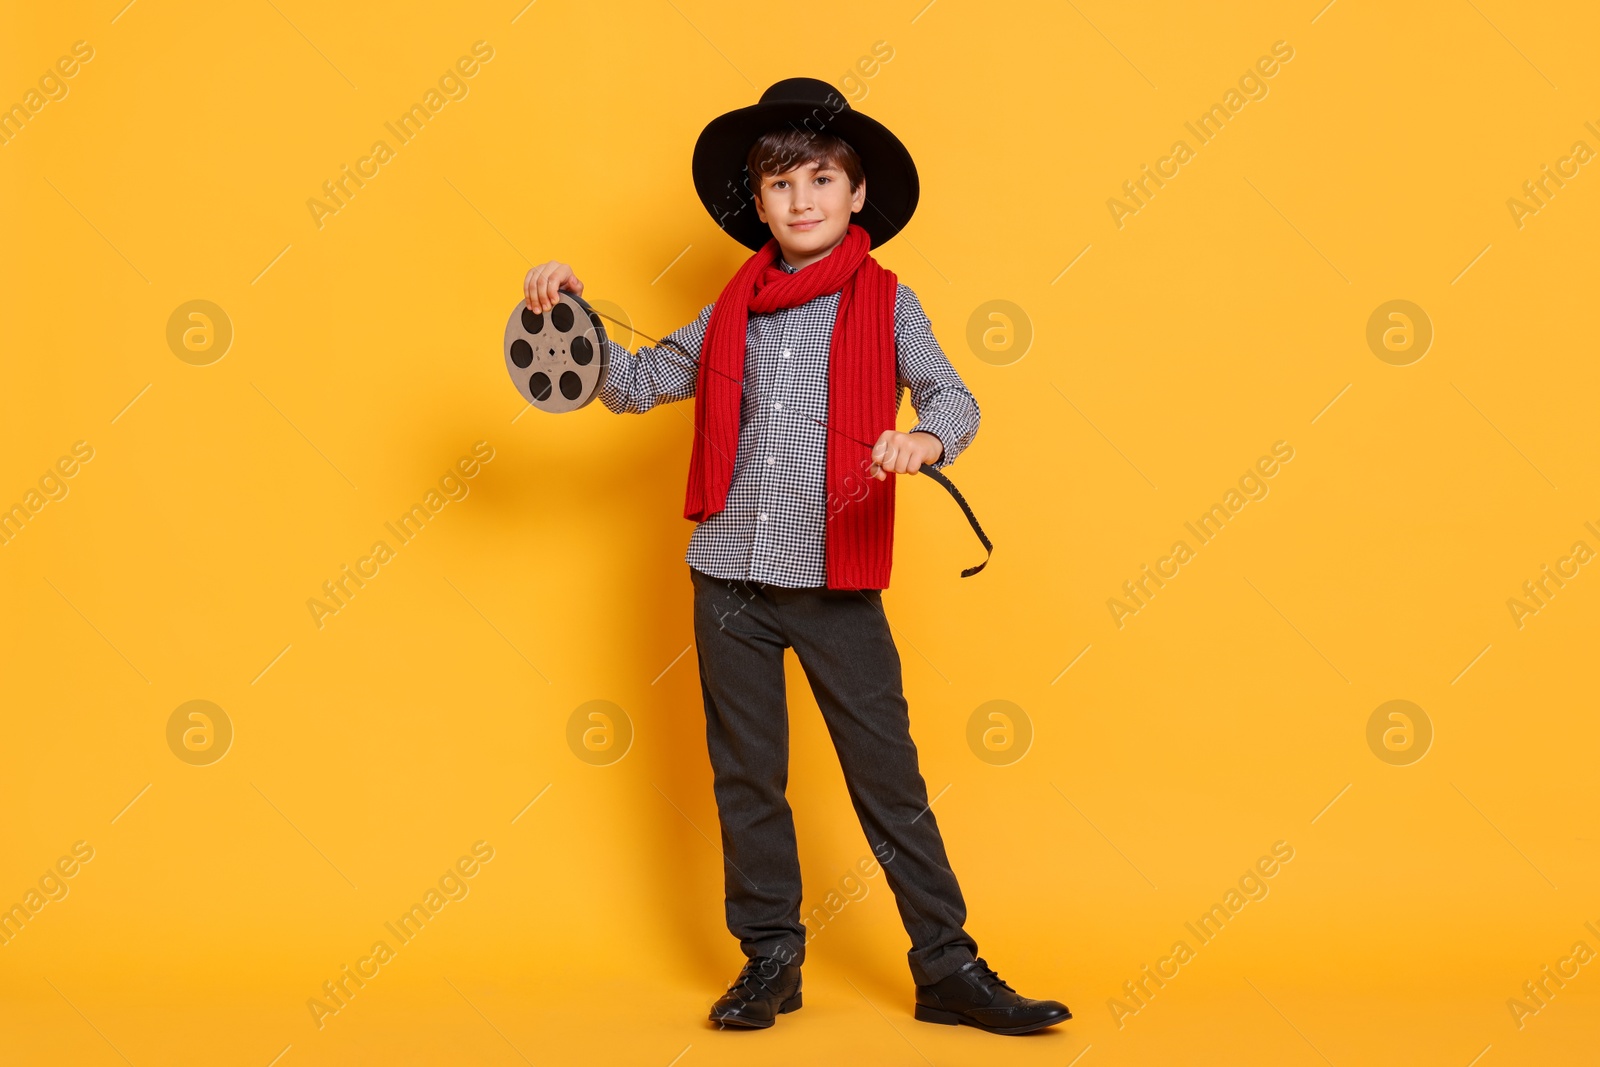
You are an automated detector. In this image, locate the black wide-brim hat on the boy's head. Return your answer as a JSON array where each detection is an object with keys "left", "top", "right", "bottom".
[{"left": 694, "top": 78, "right": 920, "bottom": 250}]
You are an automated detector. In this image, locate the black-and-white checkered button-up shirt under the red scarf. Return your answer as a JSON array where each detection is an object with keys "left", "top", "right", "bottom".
[{"left": 600, "top": 259, "right": 979, "bottom": 589}]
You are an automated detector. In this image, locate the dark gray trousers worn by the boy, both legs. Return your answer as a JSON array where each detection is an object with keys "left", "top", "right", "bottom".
[{"left": 690, "top": 566, "right": 978, "bottom": 985}]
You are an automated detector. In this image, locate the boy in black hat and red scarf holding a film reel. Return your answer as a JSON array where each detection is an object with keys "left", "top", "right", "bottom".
[{"left": 525, "top": 78, "right": 1072, "bottom": 1033}]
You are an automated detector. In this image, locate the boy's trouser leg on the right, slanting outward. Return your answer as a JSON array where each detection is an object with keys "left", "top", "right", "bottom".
[{"left": 774, "top": 590, "right": 978, "bottom": 985}]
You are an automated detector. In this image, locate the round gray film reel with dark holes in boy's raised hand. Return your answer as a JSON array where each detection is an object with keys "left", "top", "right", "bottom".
[{"left": 504, "top": 290, "right": 606, "bottom": 414}]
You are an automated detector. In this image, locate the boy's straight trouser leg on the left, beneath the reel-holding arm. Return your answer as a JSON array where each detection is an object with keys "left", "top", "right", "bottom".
[{"left": 690, "top": 568, "right": 805, "bottom": 963}]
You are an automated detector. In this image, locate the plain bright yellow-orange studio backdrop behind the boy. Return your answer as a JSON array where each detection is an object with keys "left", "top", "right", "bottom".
[{"left": 0, "top": 0, "right": 1600, "bottom": 1067}]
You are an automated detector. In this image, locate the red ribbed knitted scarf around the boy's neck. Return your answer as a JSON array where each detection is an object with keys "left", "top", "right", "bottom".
[{"left": 683, "top": 222, "right": 899, "bottom": 589}]
